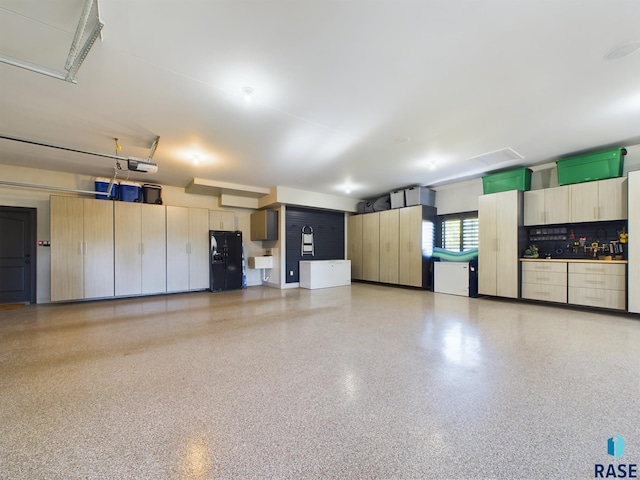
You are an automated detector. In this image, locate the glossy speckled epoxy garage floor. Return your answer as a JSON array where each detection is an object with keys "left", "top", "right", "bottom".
[{"left": 0, "top": 284, "right": 640, "bottom": 479}]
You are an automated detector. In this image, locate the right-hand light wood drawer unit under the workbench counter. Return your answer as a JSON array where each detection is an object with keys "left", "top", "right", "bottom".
[{"left": 568, "top": 262, "right": 626, "bottom": 310}]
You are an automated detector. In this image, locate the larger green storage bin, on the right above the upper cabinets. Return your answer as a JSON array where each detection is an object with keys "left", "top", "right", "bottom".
[{"left": 556, "top": 148, "right": 627, "bottom": 185}]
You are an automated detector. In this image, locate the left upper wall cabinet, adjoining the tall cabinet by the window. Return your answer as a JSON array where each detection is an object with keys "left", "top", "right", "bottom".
[{"left": 524, "top": 185, "right": 571, "bottom": 225}]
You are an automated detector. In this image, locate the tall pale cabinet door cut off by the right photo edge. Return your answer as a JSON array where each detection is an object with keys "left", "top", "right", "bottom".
[{"left": 628, "top": 170, "right": 640, "bottom": 313}]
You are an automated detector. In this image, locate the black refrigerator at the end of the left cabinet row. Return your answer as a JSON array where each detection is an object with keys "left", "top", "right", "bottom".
[{"left": 209, "top": 230, "right": 242, "bottom": 292}]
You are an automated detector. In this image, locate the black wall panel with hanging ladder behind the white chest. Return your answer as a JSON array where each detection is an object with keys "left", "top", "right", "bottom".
[{"left": 284, "top": 206, "right": 345, "bottom": 283}]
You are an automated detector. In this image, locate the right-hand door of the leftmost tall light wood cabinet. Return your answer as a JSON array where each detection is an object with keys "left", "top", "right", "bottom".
[{"left": 84, "top": 199, "right": 114, "bottom": 298}]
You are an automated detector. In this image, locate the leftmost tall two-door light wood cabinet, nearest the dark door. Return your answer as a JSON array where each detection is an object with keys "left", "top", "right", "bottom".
[{"left": 50, "top": 196, "right": 114, "bottom": 302}]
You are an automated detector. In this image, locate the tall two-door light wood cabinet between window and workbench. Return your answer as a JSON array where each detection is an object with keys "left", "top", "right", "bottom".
[{"left": 478, "top": 190, "right": 522, "bottom": 298}]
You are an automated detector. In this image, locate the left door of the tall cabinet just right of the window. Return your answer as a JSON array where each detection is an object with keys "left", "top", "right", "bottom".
[{"left": 478, "top": 194, "right": 498, "bottom": 295}]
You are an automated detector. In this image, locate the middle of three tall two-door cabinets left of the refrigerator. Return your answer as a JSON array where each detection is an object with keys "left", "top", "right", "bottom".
[{"left": 114, "top": 202, "right": 167, "bottom": 296}]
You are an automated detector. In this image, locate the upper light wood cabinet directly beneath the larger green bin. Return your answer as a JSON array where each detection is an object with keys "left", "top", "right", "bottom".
[{"left": 570, "top": 177, "right": 627, "bottom": 223}]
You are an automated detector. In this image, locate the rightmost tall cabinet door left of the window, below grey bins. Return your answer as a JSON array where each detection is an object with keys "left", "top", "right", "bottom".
[{"left": 398, "top": 205, "right": 422, "bottom": 287}]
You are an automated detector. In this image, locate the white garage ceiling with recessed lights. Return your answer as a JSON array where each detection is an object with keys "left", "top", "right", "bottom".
[{"left": 0, "top": 0, "right": 640, "bottom": 198}]
